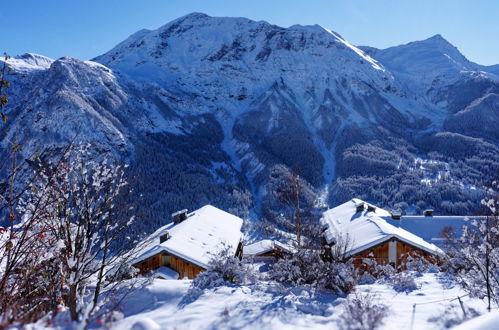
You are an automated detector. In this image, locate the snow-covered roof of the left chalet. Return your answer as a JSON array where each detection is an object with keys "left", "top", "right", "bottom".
[{"left": 133, "top": 205, "right": 243, "bottom": 269}]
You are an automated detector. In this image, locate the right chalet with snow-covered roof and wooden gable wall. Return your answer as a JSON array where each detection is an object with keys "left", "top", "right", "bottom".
[{"left": 321, "top": 199, "right": 443, "bottom": 266}]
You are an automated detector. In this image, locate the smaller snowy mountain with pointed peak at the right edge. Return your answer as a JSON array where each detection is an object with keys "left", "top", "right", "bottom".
[{"left": 361, "top": 35, "right": 499, "bottom": 141}]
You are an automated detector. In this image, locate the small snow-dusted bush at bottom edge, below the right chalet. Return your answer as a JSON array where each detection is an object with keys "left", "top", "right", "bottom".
[{"left": 339, "top": 293, "right": 389, "bottom": 330}]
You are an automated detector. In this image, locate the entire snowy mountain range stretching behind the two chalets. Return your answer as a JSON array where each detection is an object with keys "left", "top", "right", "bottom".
[{"left": 2, "top": 13, "right": 499, "bottom": 228}]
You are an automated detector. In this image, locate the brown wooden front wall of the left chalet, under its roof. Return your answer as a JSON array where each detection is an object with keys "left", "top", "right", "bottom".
[{"left": 134, "top": 253, "right": 204, "bottom": 280}]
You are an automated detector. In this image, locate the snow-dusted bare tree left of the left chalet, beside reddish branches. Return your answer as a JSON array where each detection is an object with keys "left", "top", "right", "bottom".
[{"left": 27, "top": 146, "right": 145, "bottom": 324}]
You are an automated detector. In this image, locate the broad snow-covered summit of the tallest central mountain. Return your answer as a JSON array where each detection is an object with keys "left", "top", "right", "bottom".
[{"left": 95, "top": 13, "right": 393, "bottom": 108}]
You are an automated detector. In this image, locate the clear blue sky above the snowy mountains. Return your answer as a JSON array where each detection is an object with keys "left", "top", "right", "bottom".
[{"left": 0, "top": 0, "right": 499, "bottom": 65}]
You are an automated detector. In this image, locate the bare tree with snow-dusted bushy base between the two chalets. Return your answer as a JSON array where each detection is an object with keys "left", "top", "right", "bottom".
[{"left": 269, "top": 168, "right": 357, "bottom": 294}]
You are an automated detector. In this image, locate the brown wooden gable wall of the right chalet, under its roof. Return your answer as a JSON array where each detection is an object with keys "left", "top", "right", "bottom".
[{"left": 353, "top": 238, "right": 437, "bottom": 269}]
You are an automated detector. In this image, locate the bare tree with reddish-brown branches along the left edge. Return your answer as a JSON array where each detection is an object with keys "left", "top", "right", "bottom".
[{"left": 0, "top": 56, "right": 68, "bottom": 328}]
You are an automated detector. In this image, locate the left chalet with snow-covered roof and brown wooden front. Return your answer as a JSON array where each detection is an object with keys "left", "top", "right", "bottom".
[{"left": 133, "top": 205, "right": 243, "bottom": 279}]
